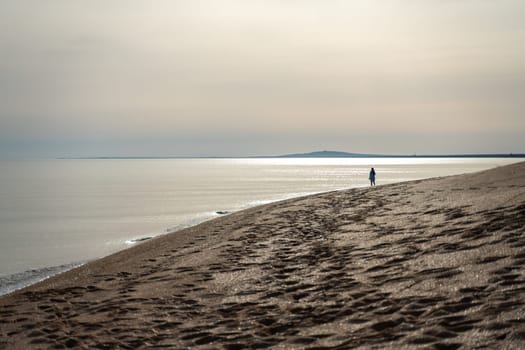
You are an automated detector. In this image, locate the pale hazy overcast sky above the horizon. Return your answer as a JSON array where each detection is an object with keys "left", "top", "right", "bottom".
[{"left": 0, "top": 0, "right": 525, "bottom": 157}]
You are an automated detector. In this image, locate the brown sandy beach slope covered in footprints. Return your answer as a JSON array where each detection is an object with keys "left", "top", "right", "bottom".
[{"left": 0, "top": 163, "right": 525, "bottom": 349}]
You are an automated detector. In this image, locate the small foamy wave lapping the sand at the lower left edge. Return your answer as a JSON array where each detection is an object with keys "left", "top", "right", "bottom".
[{"left": 0, "top": 262, "right": 85, "bottom": 295}]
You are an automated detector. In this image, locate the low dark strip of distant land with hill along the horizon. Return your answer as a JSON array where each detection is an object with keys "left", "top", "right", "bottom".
[{"left": 62, "top": 151, "right": 525, "bottom": 159}]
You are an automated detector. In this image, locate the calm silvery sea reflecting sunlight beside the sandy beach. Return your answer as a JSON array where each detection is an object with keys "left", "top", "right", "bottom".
[{"left": 0, "top": 157, "right": 524, "bottom": 295}]
